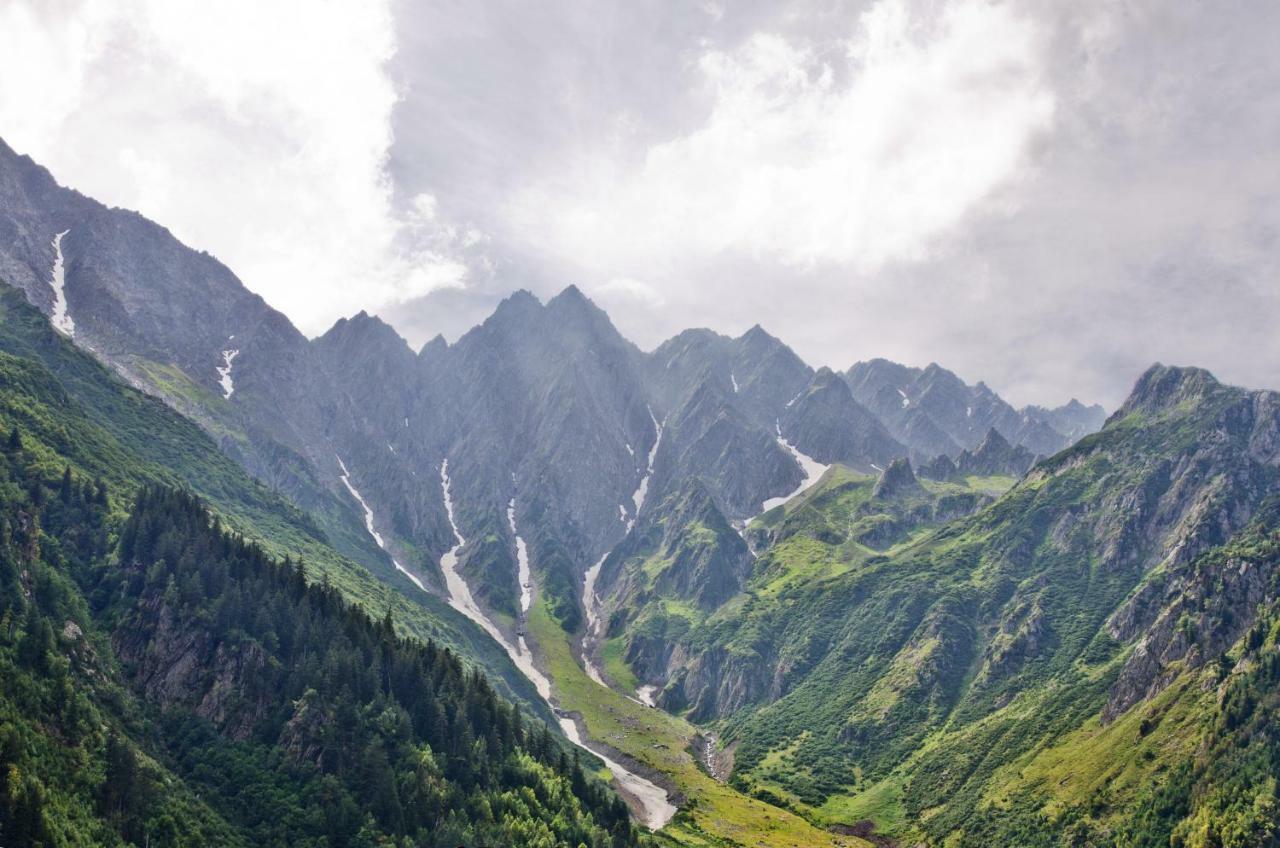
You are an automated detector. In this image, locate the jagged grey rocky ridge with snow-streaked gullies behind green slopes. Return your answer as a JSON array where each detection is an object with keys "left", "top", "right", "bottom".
[{"left": 0, "top": 137, "right": 1105, "bottom": 650}]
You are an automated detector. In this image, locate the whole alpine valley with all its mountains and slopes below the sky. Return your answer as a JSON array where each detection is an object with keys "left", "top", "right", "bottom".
[{"left": 0, "top": 133, "right": 1280, "bottom": 848}]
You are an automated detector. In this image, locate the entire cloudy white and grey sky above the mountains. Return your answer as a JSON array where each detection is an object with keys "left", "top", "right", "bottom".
[{"left": 0, "top": 0, "right": 1280, "bottom": 406}]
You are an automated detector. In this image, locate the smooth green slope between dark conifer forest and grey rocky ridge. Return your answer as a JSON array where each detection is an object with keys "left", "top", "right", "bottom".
[{"left": 0, "top": 288, "right": 549, "bottom": 717}]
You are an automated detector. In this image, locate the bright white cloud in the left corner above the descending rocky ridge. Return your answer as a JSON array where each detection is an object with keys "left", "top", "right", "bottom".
[{"left": 0, "top": 0, "right": 475, "bottom": 332}]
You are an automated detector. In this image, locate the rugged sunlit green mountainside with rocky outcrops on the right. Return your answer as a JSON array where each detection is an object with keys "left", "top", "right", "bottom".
[{"left": 604, "top": 366, "right": 1280, "bottom": 845}]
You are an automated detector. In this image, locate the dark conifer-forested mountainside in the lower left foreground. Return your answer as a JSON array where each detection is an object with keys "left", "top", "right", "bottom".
[{"left": 0, "top": 448, "right": 637, "bottom": 848}]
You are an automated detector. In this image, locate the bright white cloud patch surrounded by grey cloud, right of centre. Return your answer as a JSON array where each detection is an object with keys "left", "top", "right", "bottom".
[{"left": 513, "top": 0, "right": 1053, "bottom": 280}]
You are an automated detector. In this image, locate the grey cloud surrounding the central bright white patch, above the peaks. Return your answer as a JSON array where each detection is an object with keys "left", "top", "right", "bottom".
[{"left": 389, "top": 1, "right": 1280, "bottom": 404}]
